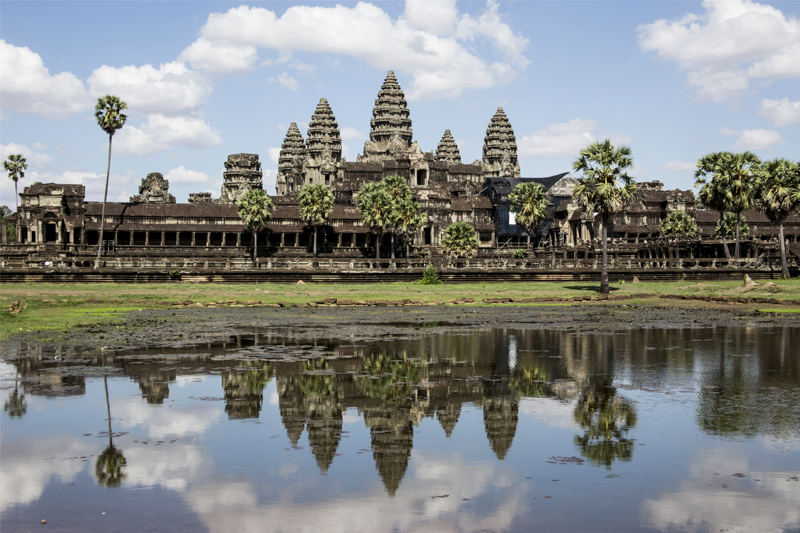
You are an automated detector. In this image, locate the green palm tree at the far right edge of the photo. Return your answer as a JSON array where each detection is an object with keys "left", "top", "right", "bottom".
[{"left": 755, "top": 159, "right": 800, "bottom": 279}]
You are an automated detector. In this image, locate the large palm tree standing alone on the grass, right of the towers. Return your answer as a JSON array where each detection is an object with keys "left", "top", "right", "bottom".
[{"left": 572, "top": 139, "right": 639, "bottom": 294}]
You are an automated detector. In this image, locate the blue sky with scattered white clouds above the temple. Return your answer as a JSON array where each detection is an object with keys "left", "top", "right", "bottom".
[{"left": 0, "top": 0, "right": 800, "bottom": 209}]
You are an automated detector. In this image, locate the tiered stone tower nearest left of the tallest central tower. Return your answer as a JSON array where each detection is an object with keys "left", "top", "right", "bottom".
[{"left": 303, "top": 98, "right": 342, "bottom": 185}]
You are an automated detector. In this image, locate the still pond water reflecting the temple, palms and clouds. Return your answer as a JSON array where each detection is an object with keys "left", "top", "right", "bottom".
[{"left": 0, "top": 327, "right": 800, "bottom": 532}]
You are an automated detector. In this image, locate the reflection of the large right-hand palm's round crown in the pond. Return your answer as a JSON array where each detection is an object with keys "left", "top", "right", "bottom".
[{"left": 574, "top": 381, "right": 636, "bottom": 469}]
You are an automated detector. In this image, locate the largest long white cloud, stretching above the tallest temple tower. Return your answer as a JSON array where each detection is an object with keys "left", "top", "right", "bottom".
[{"left": 179, "top": 0, "right": 529, "bottom": 100}]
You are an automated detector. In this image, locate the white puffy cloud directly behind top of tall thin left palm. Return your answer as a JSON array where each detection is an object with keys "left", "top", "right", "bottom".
[{"left": 88, "top": 62, "right": 211, "bottom": 115}]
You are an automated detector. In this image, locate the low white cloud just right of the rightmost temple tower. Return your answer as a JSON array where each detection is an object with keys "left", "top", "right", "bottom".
[{"left": 517, "top": 118, "right": 631, "bottom": 157}]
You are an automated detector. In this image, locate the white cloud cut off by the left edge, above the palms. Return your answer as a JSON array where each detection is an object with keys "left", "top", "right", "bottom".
[{"left": 0, "top": 40, "right": 93, "bottom": 119}]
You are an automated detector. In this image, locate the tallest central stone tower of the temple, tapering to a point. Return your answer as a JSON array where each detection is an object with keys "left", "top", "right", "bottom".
[{"left": 358, "top": 70, "right": 416, "bottom": 162}]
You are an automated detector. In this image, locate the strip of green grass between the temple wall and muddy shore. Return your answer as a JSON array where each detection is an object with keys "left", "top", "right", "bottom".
[{"left": 0, "top": 280, "right": 800, "bottom": 340}]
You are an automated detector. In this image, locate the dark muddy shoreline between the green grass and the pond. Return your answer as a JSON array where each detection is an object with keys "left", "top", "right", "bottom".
[{"left": 0, "top": 305, "right": 800, "bottom": 357}]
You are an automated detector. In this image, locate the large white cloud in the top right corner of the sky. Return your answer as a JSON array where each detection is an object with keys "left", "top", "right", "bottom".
[{"left": 638, "top": 0, "right": 800, "bottom": 102}]
